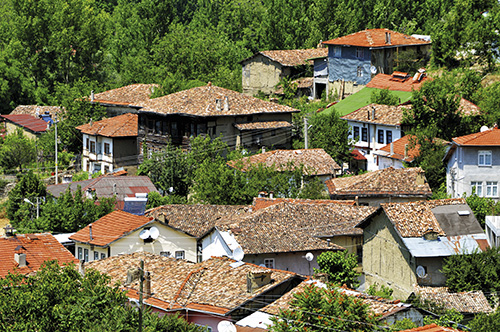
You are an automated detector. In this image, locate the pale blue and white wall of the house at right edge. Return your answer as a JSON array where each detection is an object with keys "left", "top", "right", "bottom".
[{"left": 446, "top": 147, "right": 500, "bottom": 201}]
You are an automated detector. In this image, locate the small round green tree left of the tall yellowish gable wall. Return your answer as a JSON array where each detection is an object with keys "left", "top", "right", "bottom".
[{"left": 314, "top": 250, "right": 359, "bottom": 288}]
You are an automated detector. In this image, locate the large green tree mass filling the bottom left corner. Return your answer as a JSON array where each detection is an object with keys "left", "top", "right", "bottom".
[{"left": 0, "top": 261, "right": 202, "bottom": 332}]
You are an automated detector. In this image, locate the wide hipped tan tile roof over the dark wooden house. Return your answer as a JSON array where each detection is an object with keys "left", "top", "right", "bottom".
[{"left": 140, "top": 83, "right": 298, "bottom": 117}]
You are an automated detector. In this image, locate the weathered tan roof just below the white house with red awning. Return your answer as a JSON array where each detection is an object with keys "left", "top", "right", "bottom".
[{"left": 326, "top": 167, "right": 432, "bottom": 198}]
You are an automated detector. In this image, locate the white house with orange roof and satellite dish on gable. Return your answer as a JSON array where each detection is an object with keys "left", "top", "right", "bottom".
[{"left": 70, "top": 210, "right": 197, "bottom": 262}]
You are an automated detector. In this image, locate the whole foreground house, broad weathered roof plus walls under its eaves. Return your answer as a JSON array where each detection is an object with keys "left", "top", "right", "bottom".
[{"left": 87, "top": 252, "right": 303, "bottom": 332}]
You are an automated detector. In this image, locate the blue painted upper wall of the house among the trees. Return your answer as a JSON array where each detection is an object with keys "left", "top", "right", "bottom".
[{"left": 328, "top": 45, "right": 371, "bottom": 85}]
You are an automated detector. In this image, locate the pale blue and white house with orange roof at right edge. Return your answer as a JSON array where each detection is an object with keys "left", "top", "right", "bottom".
[{"left": 444, "top": 127, "right": 500, "bottom": 201}]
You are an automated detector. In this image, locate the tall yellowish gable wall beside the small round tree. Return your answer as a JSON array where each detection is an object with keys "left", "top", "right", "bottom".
[{"left": 363, "top": 213, "right": 417, "bottom": 300}]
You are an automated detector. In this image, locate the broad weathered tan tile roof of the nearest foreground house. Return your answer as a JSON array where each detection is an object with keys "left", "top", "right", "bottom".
[{"left": 87, "top": 252, "right": 297, "bottom": 315}]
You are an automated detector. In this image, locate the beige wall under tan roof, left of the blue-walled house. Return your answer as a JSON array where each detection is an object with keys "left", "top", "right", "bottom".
[{"left": 241, "top": 54, "right": 288, "bottom": 96}]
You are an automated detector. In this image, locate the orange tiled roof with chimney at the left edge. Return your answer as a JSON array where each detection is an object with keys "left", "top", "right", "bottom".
[{"left": 0, "top": 233, "right": 79, "bottom": 278}]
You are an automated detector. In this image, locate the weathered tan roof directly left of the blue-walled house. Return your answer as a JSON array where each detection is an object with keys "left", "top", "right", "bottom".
[{"left": 240, "top": 48, "right": 328, "bottom": 67}]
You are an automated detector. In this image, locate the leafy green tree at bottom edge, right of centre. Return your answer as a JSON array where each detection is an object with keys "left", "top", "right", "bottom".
[{"left": 269, "top": 285, "right": 377, "bottom": 332}]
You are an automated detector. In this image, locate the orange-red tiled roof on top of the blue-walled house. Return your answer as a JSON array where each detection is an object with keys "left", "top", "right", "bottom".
[{"left": 323, "top": 29, "right": 430, "bottom": 48}]
